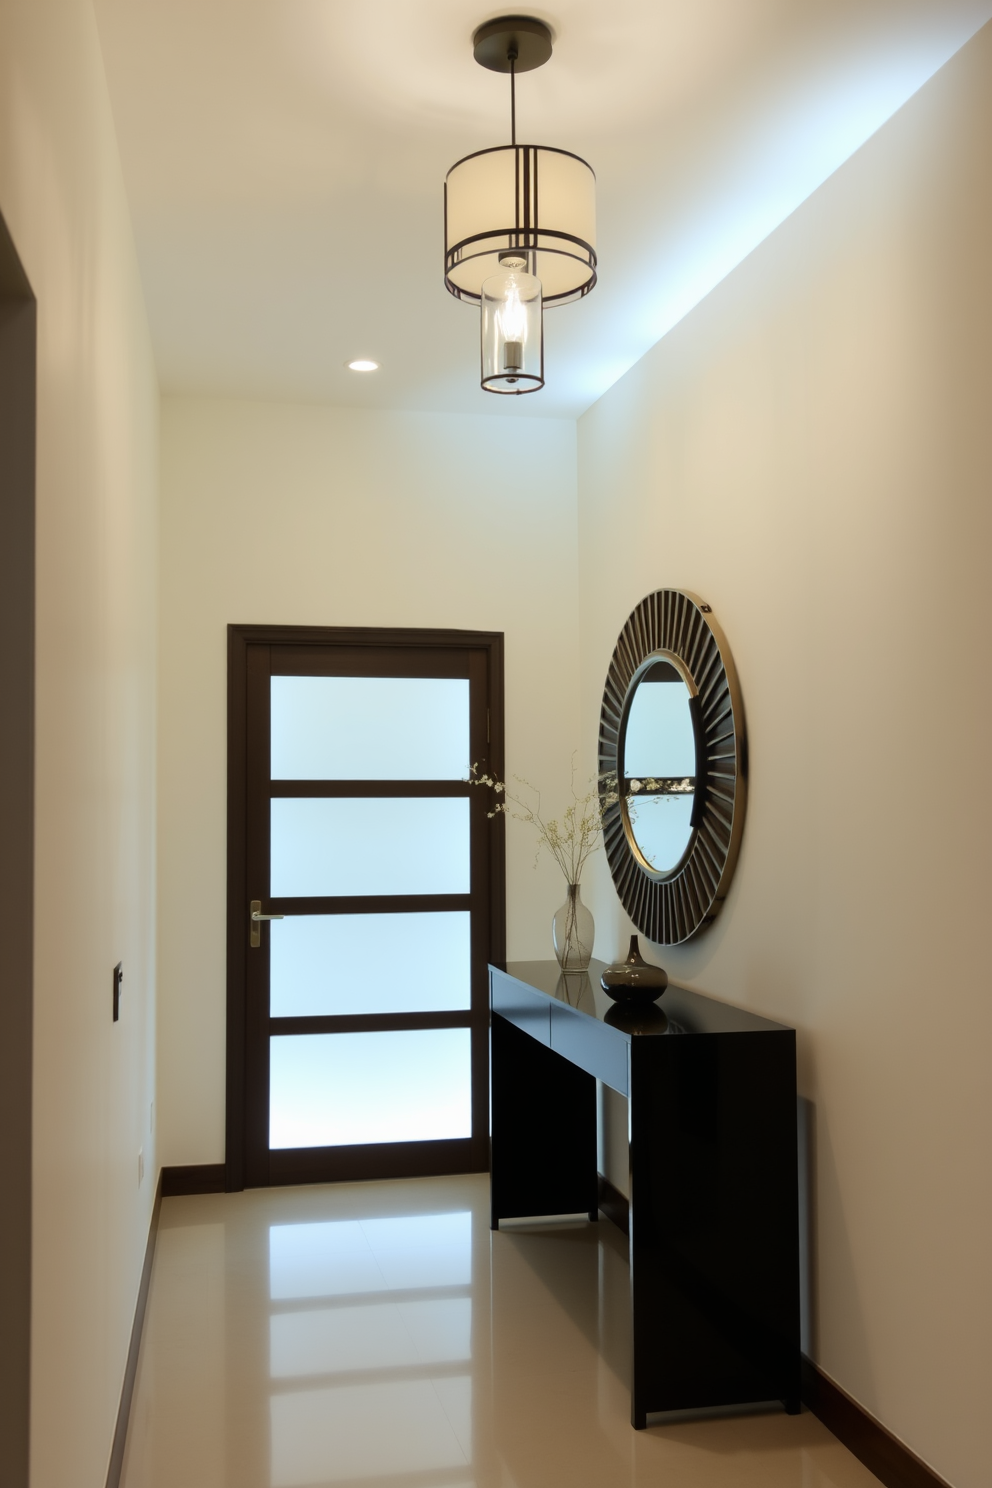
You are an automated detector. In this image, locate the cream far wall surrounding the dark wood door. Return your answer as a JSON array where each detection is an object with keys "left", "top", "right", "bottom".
[{"left": 159, "top": 399, "right": 579, "bottom": 1164}]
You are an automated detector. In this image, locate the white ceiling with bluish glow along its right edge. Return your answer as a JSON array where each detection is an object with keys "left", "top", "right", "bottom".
[{"left": 95, "top": 0, "right": 992, "bottom": 417}]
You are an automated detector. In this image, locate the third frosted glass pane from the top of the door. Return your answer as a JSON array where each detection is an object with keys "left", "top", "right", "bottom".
[{"left": 269, "top": 909, "right": 471, "bottom": 1018}]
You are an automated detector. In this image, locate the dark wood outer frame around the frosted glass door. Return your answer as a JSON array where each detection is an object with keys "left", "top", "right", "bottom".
[{"left": 225, "top": 625, "right": 506, "bottom": 1192}]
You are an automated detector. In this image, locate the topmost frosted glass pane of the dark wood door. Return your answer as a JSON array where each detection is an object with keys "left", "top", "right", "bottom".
[{"left": 272, "top": 677, "right": 471, "bottom": 780}]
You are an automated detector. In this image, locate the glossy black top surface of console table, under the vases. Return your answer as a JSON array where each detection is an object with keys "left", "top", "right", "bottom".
[{"left": 494, "top": 961, "right": 787, "bottom": 1039}]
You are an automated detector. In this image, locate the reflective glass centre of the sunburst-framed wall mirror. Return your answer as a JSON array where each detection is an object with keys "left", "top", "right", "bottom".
[{"left": 623, "top": 658, "right": 696, "bottom": 873}]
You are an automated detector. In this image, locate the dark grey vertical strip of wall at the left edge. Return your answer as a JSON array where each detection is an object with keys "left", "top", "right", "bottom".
[{"left": 0, "top": 206, "right": 36, "bottom": 1488}]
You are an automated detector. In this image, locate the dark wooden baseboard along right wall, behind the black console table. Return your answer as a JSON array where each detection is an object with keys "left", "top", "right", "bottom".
[{"left": 599, "top": 1173, "right": 950, "bottom": 1488}]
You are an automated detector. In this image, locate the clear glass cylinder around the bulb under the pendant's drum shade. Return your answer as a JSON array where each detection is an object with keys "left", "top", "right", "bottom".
[{"left": 482, "top": 263, "right": 544, "bottom": 393}]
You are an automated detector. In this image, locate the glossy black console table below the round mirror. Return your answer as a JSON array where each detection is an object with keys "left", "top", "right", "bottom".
[{"left": 489, "top": 961, "right": 800, "bottom": 1427}]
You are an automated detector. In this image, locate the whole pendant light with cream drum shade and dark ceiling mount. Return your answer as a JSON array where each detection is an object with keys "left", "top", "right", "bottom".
[{"left": 445, "top": 15, "right": 596, "bottom": 394}]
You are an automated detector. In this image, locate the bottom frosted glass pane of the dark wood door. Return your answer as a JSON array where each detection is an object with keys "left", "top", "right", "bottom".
[{"left": 269, "top": 1028, "right": 471, "bottom": 1147}]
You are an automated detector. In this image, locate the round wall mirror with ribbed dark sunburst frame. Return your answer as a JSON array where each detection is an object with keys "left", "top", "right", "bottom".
[{"left": 599, "top": 589, "right": 745, "bottom": 945}]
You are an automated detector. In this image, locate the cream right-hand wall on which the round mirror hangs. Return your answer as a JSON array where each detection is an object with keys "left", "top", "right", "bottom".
[{"left": 579, "top": 27, "right": 992, "bottom": 1488}]
